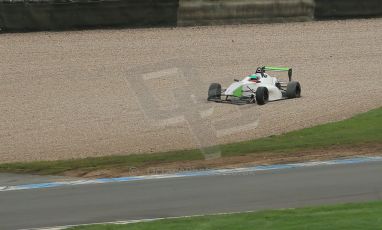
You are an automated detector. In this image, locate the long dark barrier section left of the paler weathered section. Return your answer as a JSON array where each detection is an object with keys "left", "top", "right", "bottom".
[{"left": 0, "top": 0, "right": 178, "bottom": 31}]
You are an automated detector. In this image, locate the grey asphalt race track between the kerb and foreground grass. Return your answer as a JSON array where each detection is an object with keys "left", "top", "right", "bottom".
[{"left": 0, "top": 161, "right": 382, "bottom": 230}]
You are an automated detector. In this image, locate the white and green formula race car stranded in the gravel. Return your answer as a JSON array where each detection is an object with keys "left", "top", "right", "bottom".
[{"left": 208, "top": 66, "right": 301, "bottom": 105}]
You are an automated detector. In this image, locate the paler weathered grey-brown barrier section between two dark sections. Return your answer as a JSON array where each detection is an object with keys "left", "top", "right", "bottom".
[{"left": 178, "top": 0, "right": 314, "bottom": 26}]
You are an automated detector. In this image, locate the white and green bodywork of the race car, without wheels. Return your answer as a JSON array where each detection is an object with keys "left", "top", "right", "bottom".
[{"left": 223, "top": 73, "right": 283, "bottom": 101}]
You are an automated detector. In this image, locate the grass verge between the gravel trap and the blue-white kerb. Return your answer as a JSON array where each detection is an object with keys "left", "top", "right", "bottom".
[{"left": 0, "top": 108, "right": 382, "bottom": 175}]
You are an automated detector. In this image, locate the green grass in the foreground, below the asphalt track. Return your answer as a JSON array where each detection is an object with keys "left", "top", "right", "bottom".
[{"left": 72, "top": 201, "right": 382, "bottom": 230}]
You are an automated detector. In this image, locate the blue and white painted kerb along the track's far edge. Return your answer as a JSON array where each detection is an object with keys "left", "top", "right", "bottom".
[{"left": 0, "top": 156, "right": 382, "bottom": 191}]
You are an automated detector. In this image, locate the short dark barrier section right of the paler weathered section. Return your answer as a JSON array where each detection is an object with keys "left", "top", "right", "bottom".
[{"left": 315, "top": 0, "right": 382, "bottom": 19}]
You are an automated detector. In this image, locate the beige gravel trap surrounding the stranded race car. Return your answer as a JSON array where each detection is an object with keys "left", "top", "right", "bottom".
[{"left": 0, "top": 19, "right": 382, "bottom": 162}]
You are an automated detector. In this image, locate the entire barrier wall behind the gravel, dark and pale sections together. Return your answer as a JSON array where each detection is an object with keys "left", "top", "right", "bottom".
[{"left": 0, "top": 0, "right": 382, "bottom": 31}]
